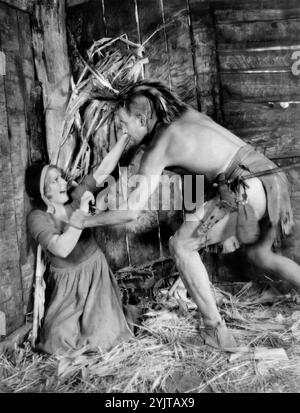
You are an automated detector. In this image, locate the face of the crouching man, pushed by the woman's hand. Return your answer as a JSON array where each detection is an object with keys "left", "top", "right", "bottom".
[{"left": 117, "top": 108, "right": 147, "bottom": 145}]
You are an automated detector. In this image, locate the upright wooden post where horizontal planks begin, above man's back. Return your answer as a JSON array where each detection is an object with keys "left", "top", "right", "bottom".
[{"left": 188, "top": 0, "right": 222, "bottom": 121}]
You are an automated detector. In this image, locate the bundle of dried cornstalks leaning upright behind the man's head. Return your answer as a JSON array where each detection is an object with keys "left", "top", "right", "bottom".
[{"left": 52, "top": 35, "right": 147, "bottom": 181}]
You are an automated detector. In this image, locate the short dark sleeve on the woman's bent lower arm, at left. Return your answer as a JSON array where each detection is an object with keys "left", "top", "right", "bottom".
[{"left": 27, "top": 210, "right": 61, "bottom": 250}]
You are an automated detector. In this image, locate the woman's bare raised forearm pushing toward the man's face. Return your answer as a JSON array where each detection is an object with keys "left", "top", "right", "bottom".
[{"left": 93, "top": 134, "right": 129, "bottom": 186}]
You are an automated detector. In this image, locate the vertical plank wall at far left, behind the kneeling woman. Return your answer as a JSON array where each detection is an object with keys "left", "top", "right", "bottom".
[{"left": 0, "top": 2, "right": 44, "bottom": 334}]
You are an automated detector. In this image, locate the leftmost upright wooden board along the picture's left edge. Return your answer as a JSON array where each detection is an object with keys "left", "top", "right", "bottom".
[{"left": 0, "top": 4, "right": 27, "bottom": 333}]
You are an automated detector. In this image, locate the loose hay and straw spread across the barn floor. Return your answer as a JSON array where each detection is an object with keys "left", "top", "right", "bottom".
[{"left": 0, "top": 283, "right": 300, "bottom": 393}]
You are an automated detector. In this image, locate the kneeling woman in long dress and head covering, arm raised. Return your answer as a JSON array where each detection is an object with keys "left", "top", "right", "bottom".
[{"left": 26, "top": 136, "right": 133, "bottom": 355}]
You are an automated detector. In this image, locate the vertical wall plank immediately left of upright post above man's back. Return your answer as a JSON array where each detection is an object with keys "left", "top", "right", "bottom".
[{"left": 163, "top": 0, "right": 197, "bottom": 108}]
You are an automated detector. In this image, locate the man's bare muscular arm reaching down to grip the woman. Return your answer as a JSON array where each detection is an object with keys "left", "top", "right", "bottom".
[{"left": 71, "top": 147, "right": 166, "bottom": 228}]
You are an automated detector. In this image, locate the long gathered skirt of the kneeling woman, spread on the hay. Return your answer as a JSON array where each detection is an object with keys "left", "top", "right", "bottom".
[{"left": 37, "top": 249, "right": 133, "bottom": 355}]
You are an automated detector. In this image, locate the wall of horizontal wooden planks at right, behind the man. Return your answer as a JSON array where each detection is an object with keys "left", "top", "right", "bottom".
[{"left": 211, "top": 0, "right": 300, "bottom": 279}]
